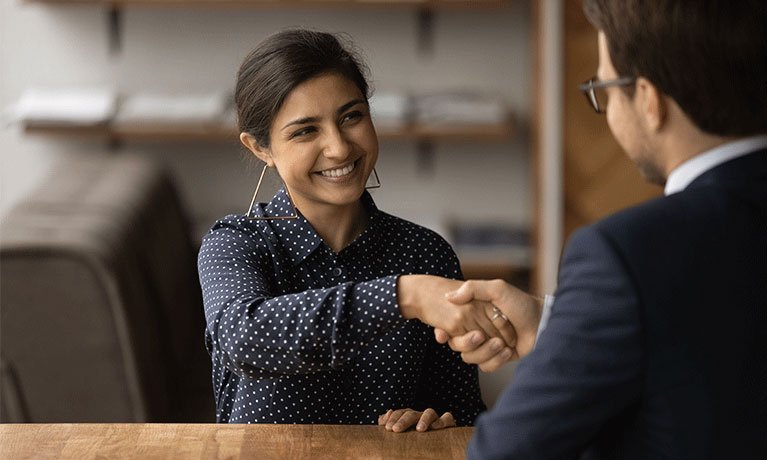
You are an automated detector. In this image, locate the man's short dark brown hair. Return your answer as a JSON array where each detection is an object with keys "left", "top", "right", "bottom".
[{"left": 583, "top": 0, "right": 767, "bottom": 136}]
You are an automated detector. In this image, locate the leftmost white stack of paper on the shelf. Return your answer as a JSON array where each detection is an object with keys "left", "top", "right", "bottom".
[{"left": 13, "top": 88, "right": 117, "bottom": 126}]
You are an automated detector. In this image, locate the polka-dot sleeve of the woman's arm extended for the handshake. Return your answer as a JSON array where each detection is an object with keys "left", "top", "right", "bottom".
[{"left": 198, "top": 224, "right": 405, "bottom": 378}]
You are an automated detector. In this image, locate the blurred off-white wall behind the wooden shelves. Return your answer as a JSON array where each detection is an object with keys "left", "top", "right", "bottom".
[{"left": 0, "top": 0, "right": 532, "bottom": 410}]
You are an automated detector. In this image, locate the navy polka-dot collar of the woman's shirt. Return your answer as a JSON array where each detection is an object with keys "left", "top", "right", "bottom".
[{"left": 261, "top": 187, "right": 381, "bottom": 266}]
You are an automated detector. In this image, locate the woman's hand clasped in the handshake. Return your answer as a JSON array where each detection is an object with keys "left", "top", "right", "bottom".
[{"left": 397, "top": 275, "right": 517, "bottom": 348}]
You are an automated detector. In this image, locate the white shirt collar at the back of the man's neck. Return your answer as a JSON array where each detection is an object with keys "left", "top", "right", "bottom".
[{"left": 664, "top": 135, "right": 767, "bottom": 195}]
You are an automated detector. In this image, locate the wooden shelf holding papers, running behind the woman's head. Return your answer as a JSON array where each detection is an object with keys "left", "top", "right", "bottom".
[{"left": 24, "top": 120, "right": 515, "bottom": 142}]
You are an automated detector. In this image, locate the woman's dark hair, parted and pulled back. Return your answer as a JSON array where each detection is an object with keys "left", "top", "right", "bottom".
[{"left": 234, "top": 29, "right": 369, "bottom": 147}]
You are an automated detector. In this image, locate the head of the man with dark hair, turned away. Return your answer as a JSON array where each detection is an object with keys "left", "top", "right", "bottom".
[{"left": 584, "top": 0, "right": 767, "bottom": 183}]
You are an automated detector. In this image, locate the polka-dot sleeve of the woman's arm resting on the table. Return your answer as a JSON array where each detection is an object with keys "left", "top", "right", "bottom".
[{"left": 417, "top": 238, "right": 486, "bottom": 426}]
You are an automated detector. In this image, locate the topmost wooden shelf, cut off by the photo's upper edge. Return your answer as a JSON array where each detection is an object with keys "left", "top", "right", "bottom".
[{"left": 24, "top": 0, "right": 511, "bottom": 9}]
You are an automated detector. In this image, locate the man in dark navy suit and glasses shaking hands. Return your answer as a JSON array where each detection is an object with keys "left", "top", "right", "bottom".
[{"left": 437, "top": 0, "right": 767, "bottom": 460}]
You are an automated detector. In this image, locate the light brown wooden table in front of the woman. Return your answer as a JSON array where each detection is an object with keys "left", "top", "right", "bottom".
[{"left": 0, "top": 423, "right": 473, "bottom": 460}]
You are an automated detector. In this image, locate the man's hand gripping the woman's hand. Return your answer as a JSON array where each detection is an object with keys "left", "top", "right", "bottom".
[{"left": 434, "top": 280, "right": 543, "bottom": 372}]
